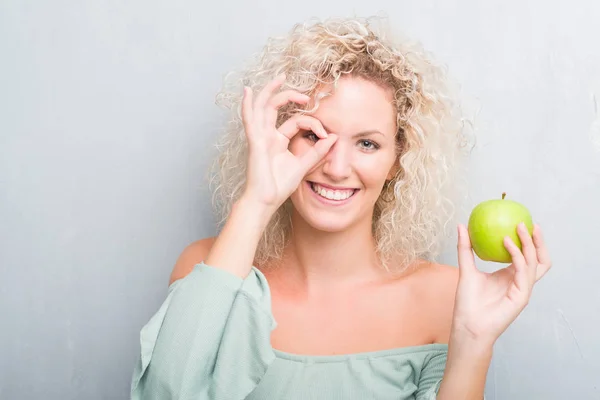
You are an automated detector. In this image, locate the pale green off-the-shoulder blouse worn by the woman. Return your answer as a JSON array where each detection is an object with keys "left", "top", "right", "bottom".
[{"left": 131, "top": 263, "right": 448, "bottom": 400}]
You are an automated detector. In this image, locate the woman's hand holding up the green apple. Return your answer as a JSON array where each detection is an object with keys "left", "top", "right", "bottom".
[{"left": 452, "top": 224, "right": 551, "bottom": 345}]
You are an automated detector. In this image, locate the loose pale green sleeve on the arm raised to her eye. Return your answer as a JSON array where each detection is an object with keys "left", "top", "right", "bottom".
[{"left": 131, "top": 263, "right": 275, "bottom": 400}]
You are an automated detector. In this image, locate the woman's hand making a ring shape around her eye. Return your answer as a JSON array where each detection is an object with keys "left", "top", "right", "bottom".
[{"left": 242, "top": 75, "right": 337, "bottom": 212}]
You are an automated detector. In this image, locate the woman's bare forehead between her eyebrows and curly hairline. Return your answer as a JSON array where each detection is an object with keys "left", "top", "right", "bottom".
[{"left": 314, "top": 77, "right": 396, "bottom": 137}]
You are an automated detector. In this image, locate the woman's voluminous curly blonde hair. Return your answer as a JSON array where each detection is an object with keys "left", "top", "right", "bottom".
[{"left": 209, "top": 18, "right": 468, "bottom": 270}]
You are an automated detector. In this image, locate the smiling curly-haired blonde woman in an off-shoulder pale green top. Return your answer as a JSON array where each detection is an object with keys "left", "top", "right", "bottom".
[{"left": 132, "top": 19, "right": 550, "bottom": 400}]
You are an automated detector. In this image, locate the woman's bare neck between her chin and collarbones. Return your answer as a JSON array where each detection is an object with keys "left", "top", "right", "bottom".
[{"left": 284, "top": 211, "right": 382, "bottom": 291}]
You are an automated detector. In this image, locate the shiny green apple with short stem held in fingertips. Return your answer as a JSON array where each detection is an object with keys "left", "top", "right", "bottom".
[{"left": 468, "top": 193, "right": 533, "bottom": 263}]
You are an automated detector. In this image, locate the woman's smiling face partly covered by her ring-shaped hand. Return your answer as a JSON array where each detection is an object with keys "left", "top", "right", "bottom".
[{"left": 289, "top": 77, "right": 397, "bottom": 232}]
